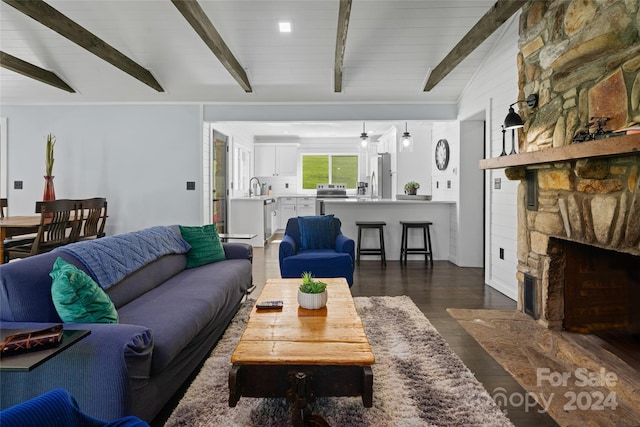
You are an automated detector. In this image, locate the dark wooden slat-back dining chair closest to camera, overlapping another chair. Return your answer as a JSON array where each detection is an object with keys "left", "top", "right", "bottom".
[{"left": 4, "top": 199, "right": 82, "bottom": 262}]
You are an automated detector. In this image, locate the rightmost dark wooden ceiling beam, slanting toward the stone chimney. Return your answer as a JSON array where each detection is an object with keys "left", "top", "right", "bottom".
[{"left": 424, "top": 0, "right": 526, "bottom": 92}]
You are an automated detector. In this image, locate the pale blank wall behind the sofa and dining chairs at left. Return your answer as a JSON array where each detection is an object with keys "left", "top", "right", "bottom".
[{"left": 2, "top": 105, "right": 202, "bottom": 234}]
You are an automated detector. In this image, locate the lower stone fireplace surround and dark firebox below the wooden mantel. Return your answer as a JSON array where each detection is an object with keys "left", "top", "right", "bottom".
[{"left": 509, "top": 154, "right": 640, "bottom": 332}]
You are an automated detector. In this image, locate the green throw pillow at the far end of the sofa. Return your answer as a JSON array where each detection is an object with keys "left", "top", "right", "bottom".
[{"left": 180, "top": 224, "right": 226, "bottom": 268}]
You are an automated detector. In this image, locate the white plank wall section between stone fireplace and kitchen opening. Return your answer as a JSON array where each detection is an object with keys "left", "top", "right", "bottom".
[{"left": 458, "top": 13, "right": 520, "bottom": 299}]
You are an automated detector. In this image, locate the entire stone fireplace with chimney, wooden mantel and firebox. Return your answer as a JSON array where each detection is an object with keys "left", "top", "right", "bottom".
[{"left": 495, "top": 0, "right": 640, "bottom": 333}]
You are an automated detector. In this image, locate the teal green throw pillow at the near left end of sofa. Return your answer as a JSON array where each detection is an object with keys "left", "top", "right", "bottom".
[{"left": 49, "top": 257, "right": 118, "bottom": 323}]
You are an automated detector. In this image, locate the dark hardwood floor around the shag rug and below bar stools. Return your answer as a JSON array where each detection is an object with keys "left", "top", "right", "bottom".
[{"left": 152, "top": 242, "right": 557, "bottom": 427}]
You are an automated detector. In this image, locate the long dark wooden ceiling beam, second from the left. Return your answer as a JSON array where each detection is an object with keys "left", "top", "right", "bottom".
[{"left": 2, "top": 0, "right": 164, "bottom": 92}]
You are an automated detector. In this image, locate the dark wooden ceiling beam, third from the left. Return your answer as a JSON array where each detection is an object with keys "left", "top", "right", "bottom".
[{"left": 171, "top": 0, "right": 253, "bottom": 93}]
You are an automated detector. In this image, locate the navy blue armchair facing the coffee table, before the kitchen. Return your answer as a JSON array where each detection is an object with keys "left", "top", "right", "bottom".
[{"left": 279, "top": 216, "right": 355, "bottom": 287}]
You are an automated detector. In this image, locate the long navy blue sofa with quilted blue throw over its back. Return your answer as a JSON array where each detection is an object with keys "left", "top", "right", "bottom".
[{"left": 0, "top": 227, "right": 252, "bottom": 421}]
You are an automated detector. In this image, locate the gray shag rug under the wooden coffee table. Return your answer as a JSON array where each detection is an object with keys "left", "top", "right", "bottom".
[{"left": 165, "top": 296, "right": 512, "bottom": 427}]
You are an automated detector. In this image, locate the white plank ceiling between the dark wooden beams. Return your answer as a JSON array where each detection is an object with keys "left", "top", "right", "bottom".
[{"left": 0, "top": 0, "right": 504, "bottom": 105}]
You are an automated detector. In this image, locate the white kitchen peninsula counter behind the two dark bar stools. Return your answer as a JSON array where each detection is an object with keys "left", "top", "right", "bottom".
[{"left": 324, "top": 198, "right": 456, "bottom": 260}]
